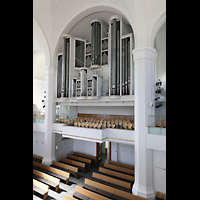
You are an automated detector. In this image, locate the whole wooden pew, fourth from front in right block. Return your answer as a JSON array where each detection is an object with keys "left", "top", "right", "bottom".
[{"left": 91, "top": 172, "right": 131, "bottom": 192}]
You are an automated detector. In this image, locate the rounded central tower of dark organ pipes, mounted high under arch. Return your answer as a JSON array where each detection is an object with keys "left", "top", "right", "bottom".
[{"left": 91, "top": 20, "right": 101, "bottom": 66}]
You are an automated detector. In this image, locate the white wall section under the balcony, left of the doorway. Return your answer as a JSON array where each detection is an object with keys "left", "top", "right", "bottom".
[{"left": 73, "top": 139, "right": 96, "bottom": 156}]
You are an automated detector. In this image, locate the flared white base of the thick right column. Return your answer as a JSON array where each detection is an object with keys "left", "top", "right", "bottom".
[{"left": 132, "top": 184, "right": 155, "bottom": 200}]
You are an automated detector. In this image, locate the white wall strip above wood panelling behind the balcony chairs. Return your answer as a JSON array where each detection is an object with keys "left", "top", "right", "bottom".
[{"left": 78, "top": 106, "right": 134, "bottom": 115}]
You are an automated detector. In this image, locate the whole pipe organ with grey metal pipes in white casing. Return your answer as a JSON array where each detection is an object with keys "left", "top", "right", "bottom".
[{"left": 57, "top": 16, "right": 134, "bottom": 99}]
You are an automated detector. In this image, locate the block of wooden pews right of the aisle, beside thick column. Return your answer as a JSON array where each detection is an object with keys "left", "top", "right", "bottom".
[{"left": 65, "top": 161, "right": 145, "bottom": 200}]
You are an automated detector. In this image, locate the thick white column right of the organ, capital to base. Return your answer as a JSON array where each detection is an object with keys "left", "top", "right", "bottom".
[{"left": 132, "top": 47, "right": 156, "bottom": 199}]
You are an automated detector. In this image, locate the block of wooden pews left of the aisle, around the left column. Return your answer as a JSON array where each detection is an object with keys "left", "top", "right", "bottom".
[{"left": 33, "top": 152, "right": 97, "bottom": 199}]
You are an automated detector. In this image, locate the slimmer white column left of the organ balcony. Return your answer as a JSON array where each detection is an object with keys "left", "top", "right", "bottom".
[{"left": 43, "top": 67, "right": 55, "bottom": 165}]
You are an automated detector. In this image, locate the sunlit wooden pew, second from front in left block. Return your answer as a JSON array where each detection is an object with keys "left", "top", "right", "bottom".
[{"left": 33, "top": 169, "right": 60, "bottom": 192}]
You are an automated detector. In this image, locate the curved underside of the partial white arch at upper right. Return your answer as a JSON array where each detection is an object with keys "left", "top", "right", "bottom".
[{"left": 150, "top": 11, "right": 166, "bottom": 47}]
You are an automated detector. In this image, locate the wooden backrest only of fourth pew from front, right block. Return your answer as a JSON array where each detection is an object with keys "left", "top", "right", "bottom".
[{"left": 92, "top": 172, "right": 131, "bottom": 189}]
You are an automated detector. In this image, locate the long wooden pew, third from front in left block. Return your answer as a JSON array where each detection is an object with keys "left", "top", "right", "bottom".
[{"left": 33, "top": 161, "right": 70, "bottom": 184}]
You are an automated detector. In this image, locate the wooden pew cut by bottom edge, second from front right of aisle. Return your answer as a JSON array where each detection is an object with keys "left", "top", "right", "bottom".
[{"left": 73, "top": 186, "right": 109, "bottom": 200}]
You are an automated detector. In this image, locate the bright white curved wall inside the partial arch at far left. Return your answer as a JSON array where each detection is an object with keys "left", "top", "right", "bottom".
[{"left": 33, "top": 17, "right": 50, "bottom": 66}]
